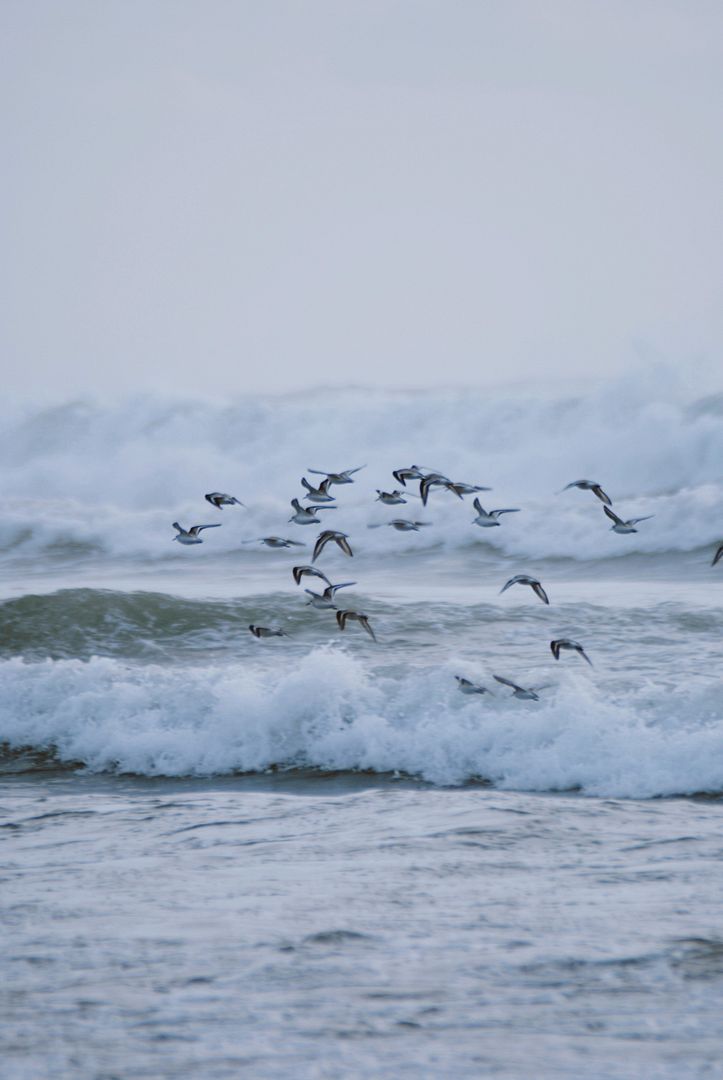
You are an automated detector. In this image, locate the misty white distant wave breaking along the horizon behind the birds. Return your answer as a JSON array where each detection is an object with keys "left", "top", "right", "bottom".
[{"left": 0, "top": 368, "right": 723, "bottom": 562}]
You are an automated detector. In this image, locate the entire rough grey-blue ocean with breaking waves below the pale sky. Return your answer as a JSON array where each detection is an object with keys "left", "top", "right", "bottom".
[{"left": 0, "top": 367, "right": 723, "bottom": 1080}]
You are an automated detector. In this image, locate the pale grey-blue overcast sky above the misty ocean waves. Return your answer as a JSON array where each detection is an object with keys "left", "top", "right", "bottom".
[{"left": 0, "top": 0, "right": 723, "bottom": 396}]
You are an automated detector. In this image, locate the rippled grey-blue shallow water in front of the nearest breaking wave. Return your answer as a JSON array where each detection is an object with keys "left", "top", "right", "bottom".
[{"left": 0, "top": 775, "right": 723, "bottom": 1080}]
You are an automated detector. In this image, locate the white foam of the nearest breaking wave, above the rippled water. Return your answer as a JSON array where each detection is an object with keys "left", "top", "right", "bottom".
[{"left": 5, "top": 649, "right": 723, "bottom": 798}]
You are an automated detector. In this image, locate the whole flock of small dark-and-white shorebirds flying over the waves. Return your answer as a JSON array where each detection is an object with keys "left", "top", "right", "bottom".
[{"left": 173, "top": 465, "right": 723, "bottom": 701}]
